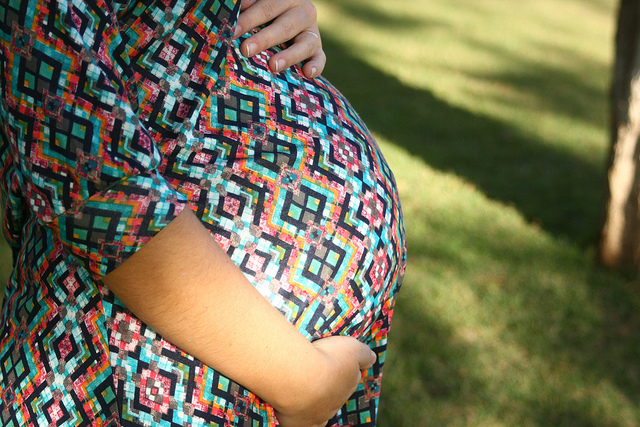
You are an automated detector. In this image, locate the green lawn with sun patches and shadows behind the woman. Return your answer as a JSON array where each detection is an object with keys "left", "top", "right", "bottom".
[{"left": 317, "top": 0, "right": 640, "bottom": 427}]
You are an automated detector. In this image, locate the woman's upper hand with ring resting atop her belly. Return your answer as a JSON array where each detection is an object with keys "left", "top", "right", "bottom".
[{"left": 234, "top": 0, "right": 327, "bottom": 78}]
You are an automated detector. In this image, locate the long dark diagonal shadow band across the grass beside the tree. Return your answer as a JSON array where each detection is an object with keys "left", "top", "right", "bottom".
[{"left": 323, "top": 35, "right": 605, "bottom": 246}]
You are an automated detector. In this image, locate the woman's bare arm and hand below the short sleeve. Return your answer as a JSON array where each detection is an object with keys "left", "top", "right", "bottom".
[{"left": 103, "top": 209, "right": 376, "bottom": 427}]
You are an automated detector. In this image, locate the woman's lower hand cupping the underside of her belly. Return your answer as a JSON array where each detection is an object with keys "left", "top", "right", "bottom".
[{"left": 275, "top": 336, "right": 376, "bottom": 427}]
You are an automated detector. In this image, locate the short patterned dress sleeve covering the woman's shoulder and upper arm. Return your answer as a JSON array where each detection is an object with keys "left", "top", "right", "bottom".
[{"left": 0, "top": 0, "right": 187, "bottom": 279}]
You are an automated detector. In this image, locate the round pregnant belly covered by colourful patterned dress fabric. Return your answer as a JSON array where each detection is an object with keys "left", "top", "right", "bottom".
[{"left": 163, "top": 40, "right": 404, "bottom": 338}]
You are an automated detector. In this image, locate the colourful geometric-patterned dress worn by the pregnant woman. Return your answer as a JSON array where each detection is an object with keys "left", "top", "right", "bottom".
[{"left": 0, "top": 0, "right": 405, "bottom": 427}]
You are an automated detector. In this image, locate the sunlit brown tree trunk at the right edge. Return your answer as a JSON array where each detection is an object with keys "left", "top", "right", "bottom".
[{"left": 598, "top": 0, "right": 640, "bottom": 269}]
